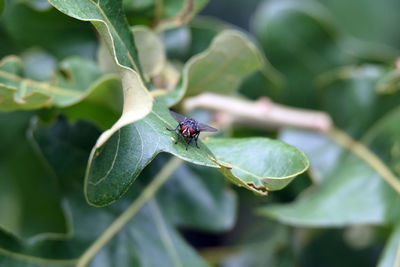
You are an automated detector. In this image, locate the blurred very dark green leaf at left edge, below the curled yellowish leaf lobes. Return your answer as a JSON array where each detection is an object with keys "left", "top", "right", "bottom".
[{"left": 0, "top": 112, "right": 70, "bottom": 240}]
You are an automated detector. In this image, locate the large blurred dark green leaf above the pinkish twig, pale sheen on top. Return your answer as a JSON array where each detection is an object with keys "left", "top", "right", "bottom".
[{"left": 252, "top": 0, "right": 344, "bottom": 107}]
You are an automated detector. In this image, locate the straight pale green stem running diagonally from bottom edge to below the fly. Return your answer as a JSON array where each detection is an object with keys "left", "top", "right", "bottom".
[{"left": 76, "top": 157, "right": 182, "bottom": 267}]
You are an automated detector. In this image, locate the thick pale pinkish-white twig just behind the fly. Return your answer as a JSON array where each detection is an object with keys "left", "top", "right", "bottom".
[{"left": 183, "top": 93, "right": 332, "bottom": 132}]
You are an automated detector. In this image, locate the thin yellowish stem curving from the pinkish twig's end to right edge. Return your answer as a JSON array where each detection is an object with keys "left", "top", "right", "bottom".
[{"left": 328, "top": 127, "right": 400, "bottom": 194}]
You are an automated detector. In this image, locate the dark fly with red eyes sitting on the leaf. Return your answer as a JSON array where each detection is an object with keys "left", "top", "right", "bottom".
[{"left": 166, "top": 111, "right": 217, "bottom": 150}]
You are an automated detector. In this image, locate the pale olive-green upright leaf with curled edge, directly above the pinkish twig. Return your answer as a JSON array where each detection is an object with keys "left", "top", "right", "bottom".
[{"left": 159, "top": 30, "right": 264, "bottom": 106}]
